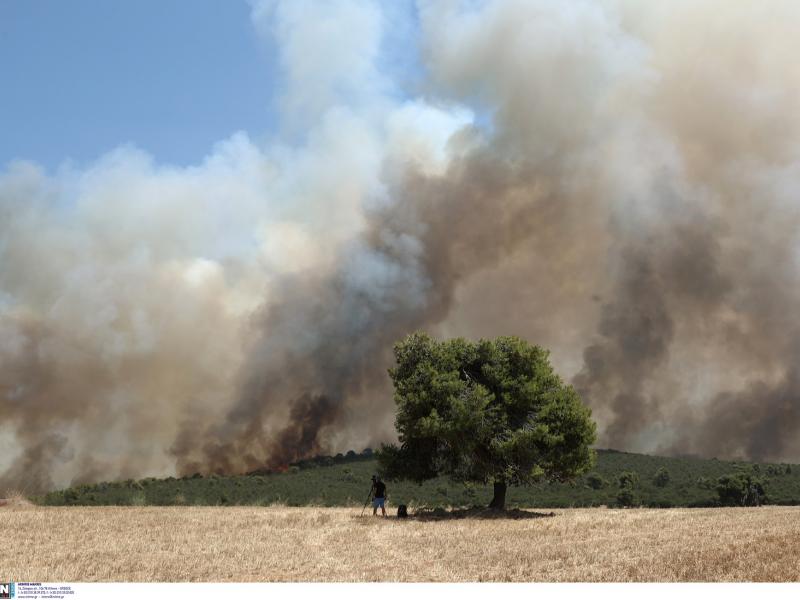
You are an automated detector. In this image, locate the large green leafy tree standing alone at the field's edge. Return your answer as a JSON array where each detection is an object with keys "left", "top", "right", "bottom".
[{"left": 378, "top": 332, "right": 595, "bottom": 509}]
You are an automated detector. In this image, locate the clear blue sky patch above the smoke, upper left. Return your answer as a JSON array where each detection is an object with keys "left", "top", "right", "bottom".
[{"left": 0, "top": 0, "right": 276, "bottom": 170}]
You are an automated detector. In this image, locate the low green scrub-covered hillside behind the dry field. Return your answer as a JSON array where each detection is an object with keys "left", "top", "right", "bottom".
[{"left": 33, "top": 450, "right": 800, "bottom": 508}]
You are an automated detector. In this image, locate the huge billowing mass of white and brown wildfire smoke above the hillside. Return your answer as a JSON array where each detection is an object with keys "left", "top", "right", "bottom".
[{"left": 0, "top": 0, "right": 800, "bottom": 492}]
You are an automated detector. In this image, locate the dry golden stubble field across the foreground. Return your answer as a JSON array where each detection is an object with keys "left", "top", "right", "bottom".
[{"left": 0, "top": 504, "right": 800, "bottom": 582}]
